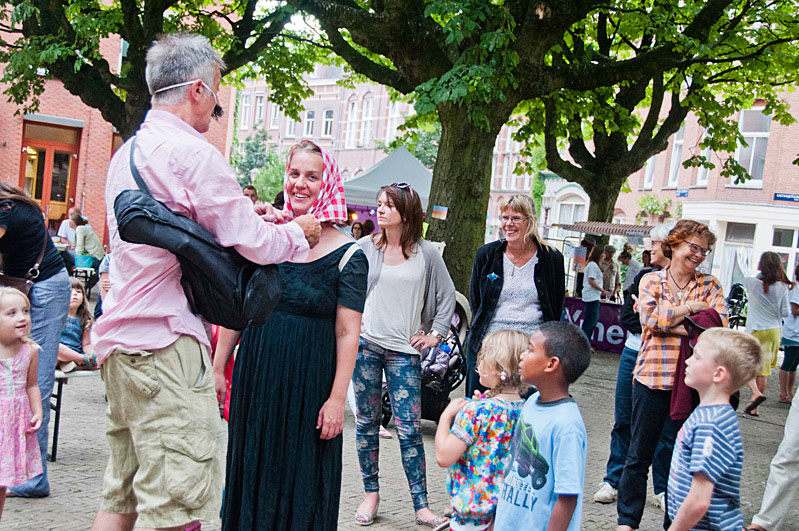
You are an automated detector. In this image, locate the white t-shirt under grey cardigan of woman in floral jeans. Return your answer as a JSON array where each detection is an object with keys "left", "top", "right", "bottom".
[{"left": 361, "top": 245, "right": 425, "bottom": 354}]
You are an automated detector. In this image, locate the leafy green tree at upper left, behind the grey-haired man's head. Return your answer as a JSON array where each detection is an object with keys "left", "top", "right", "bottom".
[{"left": 0, "top": 0, "right": 320, "bottom": 139}]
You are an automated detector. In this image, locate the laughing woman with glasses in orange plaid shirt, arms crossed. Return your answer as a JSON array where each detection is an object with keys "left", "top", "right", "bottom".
[{"left": 616, "top": 219, "right": 727, "bottom": 531}]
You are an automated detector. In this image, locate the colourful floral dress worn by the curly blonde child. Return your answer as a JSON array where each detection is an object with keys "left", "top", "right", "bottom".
[{"left": 447, "top": 398, "right": 524, "bottom": 527}]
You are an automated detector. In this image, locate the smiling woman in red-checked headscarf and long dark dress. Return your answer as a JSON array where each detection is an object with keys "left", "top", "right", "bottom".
[{"left": 214, "top": 140, "right": 368, "bottom": 530}]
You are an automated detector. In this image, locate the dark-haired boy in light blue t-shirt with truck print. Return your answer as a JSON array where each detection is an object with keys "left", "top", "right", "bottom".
[{"left": 494, "top": 321, "right": 591, "bottom": 531}]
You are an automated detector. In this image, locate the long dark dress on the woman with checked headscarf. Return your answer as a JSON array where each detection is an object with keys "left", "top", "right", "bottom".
[{"left": 222, "top": 244, "right": 368, "bottom": 531}]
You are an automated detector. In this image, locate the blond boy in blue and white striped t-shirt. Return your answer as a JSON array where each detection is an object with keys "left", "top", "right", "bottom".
[{"left": 666, "top": 328, "right": 761, "bottom": 531}]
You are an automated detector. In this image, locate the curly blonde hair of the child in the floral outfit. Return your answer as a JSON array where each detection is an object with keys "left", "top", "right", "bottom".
[{"left": 477, "top": 330, "right": 530, "bottom": 397}]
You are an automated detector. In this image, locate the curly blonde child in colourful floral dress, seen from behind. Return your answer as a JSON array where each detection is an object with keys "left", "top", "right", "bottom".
[{"left": 436, "top": 330, "right": 528, "bottom": 530}]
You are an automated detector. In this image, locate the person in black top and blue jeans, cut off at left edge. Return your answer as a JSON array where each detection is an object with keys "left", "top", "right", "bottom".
[{"left": 0, "top": 182, "right": 71, "bottom": 498}]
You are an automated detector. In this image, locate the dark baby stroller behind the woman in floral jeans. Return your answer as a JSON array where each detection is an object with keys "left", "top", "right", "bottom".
[{"left": 381, "top": 292, "right": 472, "bottom": 427}]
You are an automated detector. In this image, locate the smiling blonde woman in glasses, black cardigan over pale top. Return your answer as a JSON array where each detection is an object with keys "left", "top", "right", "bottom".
[{"left": 466, "top": 194, "right": 566, "bottom": 397}]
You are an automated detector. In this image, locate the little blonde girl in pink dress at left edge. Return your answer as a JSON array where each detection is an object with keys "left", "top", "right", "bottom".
[{"left": 0, "top": 287, "right": 42, "bottom": 516}]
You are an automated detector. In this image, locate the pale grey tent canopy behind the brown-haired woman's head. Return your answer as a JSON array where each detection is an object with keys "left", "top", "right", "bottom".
[{"left": 344, "top": 146, "right": 433, "bottom": 210}]
